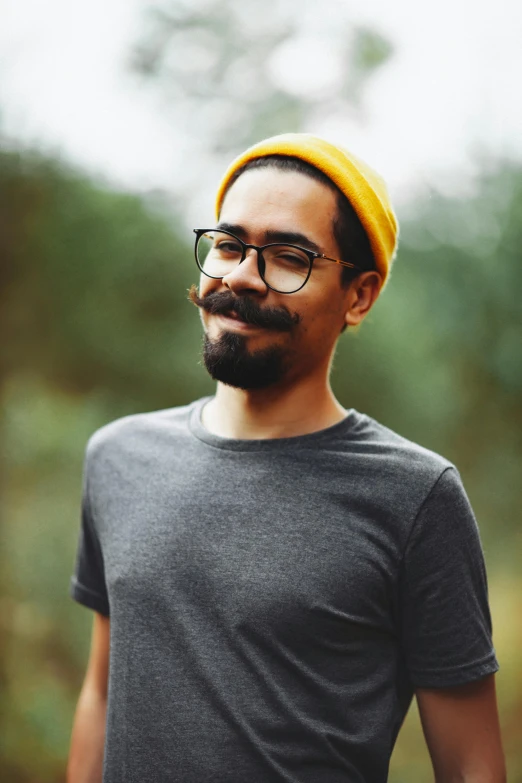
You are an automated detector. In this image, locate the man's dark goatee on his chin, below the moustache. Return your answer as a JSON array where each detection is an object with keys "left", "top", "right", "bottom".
[{"left": 203, "top": 332, "right": 285, "bottom": 390}]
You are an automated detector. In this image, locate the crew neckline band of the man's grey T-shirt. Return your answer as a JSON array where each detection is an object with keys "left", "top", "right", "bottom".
[{"left": 188, "top": 397, "right": 357, "bottom": 451}]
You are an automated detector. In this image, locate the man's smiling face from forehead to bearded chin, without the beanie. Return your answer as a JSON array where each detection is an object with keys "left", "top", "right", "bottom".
[{"left": 195, "top": 168, "right": 358, "bottom": 388}]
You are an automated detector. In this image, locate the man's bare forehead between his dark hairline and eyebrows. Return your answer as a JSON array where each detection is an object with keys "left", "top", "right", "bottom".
[{"left": 216, "top": 167, "right": 337, "bottom": 245}]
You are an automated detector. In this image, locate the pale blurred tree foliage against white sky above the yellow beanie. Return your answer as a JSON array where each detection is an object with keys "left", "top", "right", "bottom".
[{"left": 132, "top": 0, "right": 392, "bottom": 160}]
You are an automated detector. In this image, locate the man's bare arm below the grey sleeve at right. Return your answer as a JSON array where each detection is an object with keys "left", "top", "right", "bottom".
[{"left": 416, "top": 675, "right": 506, "bottom": 783}]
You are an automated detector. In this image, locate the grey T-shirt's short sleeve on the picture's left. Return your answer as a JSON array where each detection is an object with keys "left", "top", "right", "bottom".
[{"left": 70, "top": 460, "right": 109, "bottom": 617}]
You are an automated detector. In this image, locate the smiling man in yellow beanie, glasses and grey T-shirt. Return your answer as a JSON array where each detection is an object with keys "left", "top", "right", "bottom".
[{"left": 68, "top": 134, "right": 505, "bottom": 783}]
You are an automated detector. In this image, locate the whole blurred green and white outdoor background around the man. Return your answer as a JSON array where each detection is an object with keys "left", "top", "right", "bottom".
[{"left": 0, "top": 0, "right": 522, "bottom": 783}]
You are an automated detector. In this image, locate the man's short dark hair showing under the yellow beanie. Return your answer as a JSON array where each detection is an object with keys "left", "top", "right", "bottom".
[{"left": 222, "top": 155, "right": 376, "bottom": 286}]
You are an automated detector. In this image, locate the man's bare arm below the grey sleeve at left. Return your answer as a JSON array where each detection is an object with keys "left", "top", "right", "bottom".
[{"left": 67, "top": 613, "right": 110, "bottom": 783}]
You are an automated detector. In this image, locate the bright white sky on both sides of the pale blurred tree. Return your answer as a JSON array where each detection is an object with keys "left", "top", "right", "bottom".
[{"left": 0, "top": 0, "right": 522, "bottom": 216}]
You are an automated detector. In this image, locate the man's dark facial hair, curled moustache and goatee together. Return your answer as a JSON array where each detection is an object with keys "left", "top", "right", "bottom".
[{"left": 189, "top": 286, "right": 300, "bottom": 390}]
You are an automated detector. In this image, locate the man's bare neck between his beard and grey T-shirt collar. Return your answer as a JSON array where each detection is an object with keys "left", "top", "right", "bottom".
[{"left": 203, "top": 377, "right": 346, "bottom": 440}]
